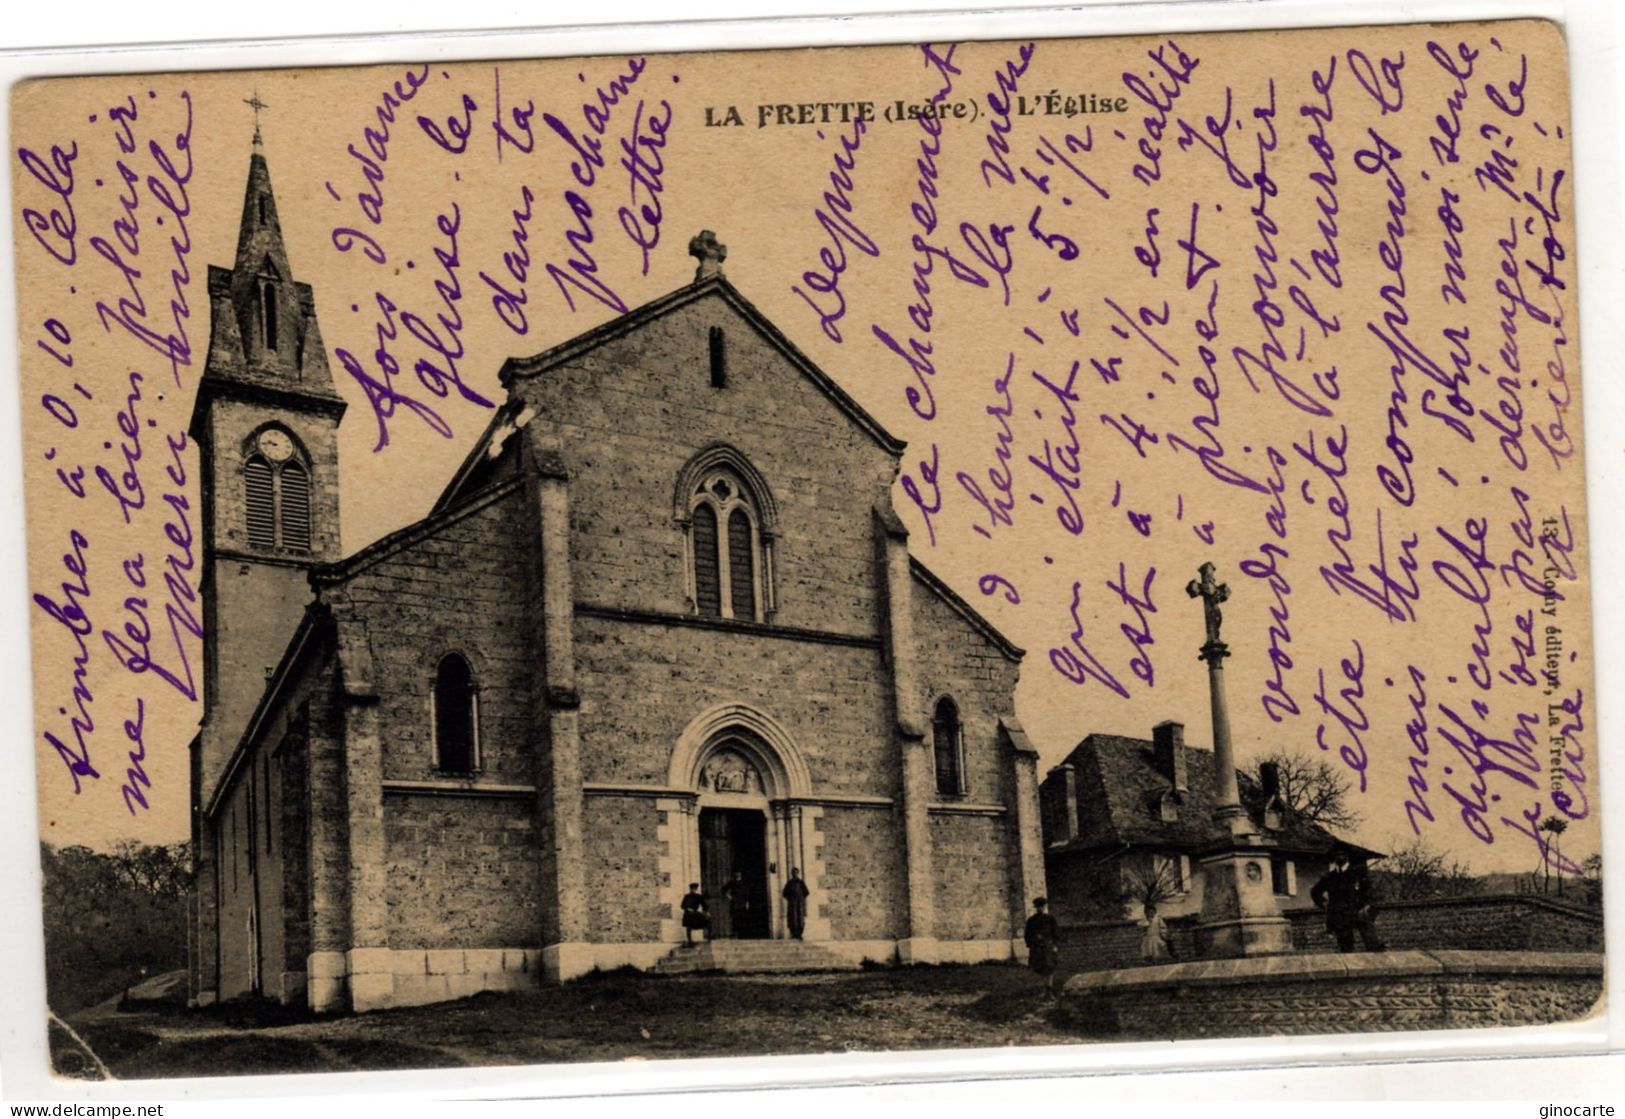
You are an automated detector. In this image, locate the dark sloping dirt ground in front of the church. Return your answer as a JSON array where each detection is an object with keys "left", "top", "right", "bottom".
[{"left": 52, "top": 965, "right": 1086, "bottom": 1078}]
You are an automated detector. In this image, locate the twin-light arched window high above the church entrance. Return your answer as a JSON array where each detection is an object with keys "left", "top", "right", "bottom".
[{"left": 689, "top": 468, "right": 764, "bottom": 622}]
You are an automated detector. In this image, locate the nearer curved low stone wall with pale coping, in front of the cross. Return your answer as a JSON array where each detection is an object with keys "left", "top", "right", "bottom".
[{"left": 1061, "top": 950, "right": 1602, "bottom": 1039}]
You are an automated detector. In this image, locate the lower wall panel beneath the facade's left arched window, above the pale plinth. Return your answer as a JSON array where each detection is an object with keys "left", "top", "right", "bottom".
[{"left": 384, "top": 794, "right": 541, "bottom": 950}]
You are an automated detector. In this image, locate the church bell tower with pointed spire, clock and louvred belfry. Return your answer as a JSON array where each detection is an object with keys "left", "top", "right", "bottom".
[{"left": 190, "top": 124, "right": 345, "bottom": 795}]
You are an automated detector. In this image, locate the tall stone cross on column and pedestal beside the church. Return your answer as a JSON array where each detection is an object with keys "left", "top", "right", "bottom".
[{"left": 1185, "top": 564, "right": 1292, "bottom": 957}]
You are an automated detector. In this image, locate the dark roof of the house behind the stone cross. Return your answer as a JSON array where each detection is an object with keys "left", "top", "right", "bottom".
[{"left": 1050, "top": 734, "right": 1380, "bottom": 858}]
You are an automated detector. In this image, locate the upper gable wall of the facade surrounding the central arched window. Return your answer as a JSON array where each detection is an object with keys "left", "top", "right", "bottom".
[{"left": 515, "top": 287, "right": 895, "bottom": 635}]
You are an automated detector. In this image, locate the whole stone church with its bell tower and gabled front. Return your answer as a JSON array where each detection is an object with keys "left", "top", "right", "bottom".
[{"left": 190, "top": 148, "right": 1043, "bottom": 1010}]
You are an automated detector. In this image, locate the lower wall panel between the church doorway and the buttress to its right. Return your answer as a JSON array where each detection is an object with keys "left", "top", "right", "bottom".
[{"left": 819, "top": 806, "right": 908, "bottom": 940}]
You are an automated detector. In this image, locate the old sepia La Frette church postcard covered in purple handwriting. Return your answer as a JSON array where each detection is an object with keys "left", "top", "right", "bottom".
[{"left": 10, "top": 8, "right": 1604, "bottom": 1078}]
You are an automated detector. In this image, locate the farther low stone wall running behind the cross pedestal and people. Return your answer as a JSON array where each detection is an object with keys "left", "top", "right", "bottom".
[{"left": 1061, "top": 893, "right": 1602, "bottom": 973}]
